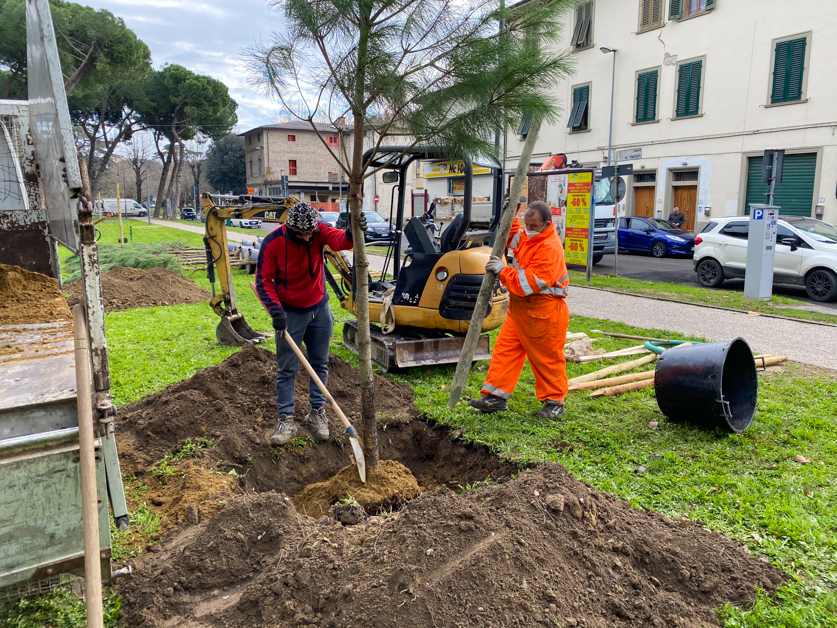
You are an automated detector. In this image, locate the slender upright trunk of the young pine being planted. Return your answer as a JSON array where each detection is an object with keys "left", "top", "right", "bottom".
[{"left": 349, "top": 16, "right": 379, "bottom": 470}]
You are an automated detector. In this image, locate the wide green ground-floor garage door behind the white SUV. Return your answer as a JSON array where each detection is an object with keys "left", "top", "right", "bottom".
[{"left": 744, "top": 153, "right": 817, "bottom": 216}]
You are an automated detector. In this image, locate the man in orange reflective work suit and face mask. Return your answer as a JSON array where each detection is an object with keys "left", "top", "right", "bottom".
[{"left": 471, "top": 201, "right": 570, "bottom": 419}]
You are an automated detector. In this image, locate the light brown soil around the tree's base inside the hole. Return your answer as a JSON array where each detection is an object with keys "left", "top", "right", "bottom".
[{"left": 293, "top": 460, "right": 420, "bottom": 518}]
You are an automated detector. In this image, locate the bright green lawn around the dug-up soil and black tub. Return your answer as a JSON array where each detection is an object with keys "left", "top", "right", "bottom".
[{"left": 8, "top": 225, "right": 837, "bottom": 628}]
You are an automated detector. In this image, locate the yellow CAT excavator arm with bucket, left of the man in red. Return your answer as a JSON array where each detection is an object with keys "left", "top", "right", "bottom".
[{"left": 201, "top": 194, "right": 299, "bottom": 345}]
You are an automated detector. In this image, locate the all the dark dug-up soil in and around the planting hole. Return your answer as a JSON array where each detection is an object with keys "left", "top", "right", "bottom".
[{"left": 118, "top": 347, "right": 786, "bottom": 628}]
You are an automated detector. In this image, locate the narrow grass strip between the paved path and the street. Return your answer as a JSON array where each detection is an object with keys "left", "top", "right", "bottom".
[{"left": 570, "top": 270, "right": 837, "bottom": 324}]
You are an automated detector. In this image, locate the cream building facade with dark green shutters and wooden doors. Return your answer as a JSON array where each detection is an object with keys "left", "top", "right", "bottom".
[{"left": 506, "top": 0, "right": 837, "bottom": 231}]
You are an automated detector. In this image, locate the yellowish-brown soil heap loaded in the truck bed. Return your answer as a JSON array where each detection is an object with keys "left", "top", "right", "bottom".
[{"left": 0, "top": 264, "right": 73, "bottom": 325}]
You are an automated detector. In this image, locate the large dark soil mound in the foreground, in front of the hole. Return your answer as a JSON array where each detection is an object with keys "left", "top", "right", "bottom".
[{"left": 121, "top": 464, "right": 785, "bottom": 628}]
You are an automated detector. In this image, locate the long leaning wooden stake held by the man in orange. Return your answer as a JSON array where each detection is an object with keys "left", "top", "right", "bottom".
[{"left": 448, "top": 118, "right": 541, "bottom": 410}]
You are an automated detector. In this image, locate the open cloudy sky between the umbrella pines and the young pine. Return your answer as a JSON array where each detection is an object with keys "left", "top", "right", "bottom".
[{"left": 81, "top": 0, "right": 282, "bottom": 132}]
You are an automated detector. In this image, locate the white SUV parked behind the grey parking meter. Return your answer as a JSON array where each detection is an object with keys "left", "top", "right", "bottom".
[{"left": 692, "top": 215, "right": 837, "bottom": 301}]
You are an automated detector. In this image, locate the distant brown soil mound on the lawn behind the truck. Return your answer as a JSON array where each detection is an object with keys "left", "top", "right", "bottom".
[{"left": 64, "top": 266, "right": 211, "bottom": 312}]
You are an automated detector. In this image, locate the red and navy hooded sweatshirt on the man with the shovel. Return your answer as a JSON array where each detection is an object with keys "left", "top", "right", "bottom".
[{"left": 251, "top": 222, "right": 352, "bottom": 316}]
